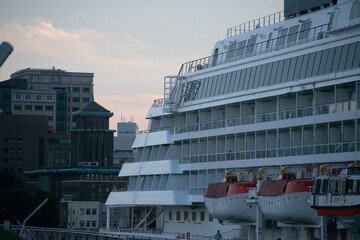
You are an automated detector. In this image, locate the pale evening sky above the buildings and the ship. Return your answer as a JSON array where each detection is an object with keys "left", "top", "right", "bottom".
[{"left": 0, "top": 0, "right": 284, "bottom": 130}]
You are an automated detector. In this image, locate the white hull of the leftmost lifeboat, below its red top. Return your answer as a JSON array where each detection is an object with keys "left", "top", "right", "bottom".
[{"left": 204, "top": 193, "right": 256, "bottom": 223}]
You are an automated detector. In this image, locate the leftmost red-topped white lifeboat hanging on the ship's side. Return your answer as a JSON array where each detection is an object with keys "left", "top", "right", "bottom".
[{"left": 204, "top": 172, "right": 256, "bottom": 223}]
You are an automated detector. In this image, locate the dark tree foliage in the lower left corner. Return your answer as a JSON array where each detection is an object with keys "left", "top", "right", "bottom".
[{"left": 0, "top": 171, "right": 59, "bottom": 228}]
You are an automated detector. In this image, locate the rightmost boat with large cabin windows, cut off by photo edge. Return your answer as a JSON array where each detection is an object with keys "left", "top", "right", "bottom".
[{"left": 311, "top": 167, "right": 360, "bottom": 218}]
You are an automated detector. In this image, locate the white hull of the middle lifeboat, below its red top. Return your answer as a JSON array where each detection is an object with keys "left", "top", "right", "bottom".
[{"left": 258, "top": 192, "right": 320, "bottom": 224}]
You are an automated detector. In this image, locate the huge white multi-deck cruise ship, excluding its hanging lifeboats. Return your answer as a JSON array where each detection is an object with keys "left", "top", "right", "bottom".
[{"left": 106, "top": 0, "right": 360, "bottom": 239}]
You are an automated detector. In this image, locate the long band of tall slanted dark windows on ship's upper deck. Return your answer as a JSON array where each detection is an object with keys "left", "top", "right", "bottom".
[{"left": 184, "top": 42, "right": 360, "bottom": 100}]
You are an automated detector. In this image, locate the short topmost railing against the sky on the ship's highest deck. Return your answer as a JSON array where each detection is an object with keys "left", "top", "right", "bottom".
[{"left": 226, "top": 11, "right": 285, "bottom": 38}]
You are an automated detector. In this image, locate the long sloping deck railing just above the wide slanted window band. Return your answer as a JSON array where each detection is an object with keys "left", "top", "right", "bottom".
[{"left": 179, "top": 24, "right": 329, "bottom": 76}]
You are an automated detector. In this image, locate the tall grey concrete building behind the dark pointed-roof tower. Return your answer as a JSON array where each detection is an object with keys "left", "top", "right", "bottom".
[{"left": 7, "top": 68, "right": 94, "bottom": 133}]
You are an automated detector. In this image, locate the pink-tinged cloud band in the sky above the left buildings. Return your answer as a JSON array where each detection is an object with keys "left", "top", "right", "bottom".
[{"left": 0, "top": 19, "right": 169, "bottom": 67}]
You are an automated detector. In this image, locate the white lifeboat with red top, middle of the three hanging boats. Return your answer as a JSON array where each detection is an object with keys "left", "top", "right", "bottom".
[{"left": 257, "top": 173, "right": 320, "bottom": 224}]
